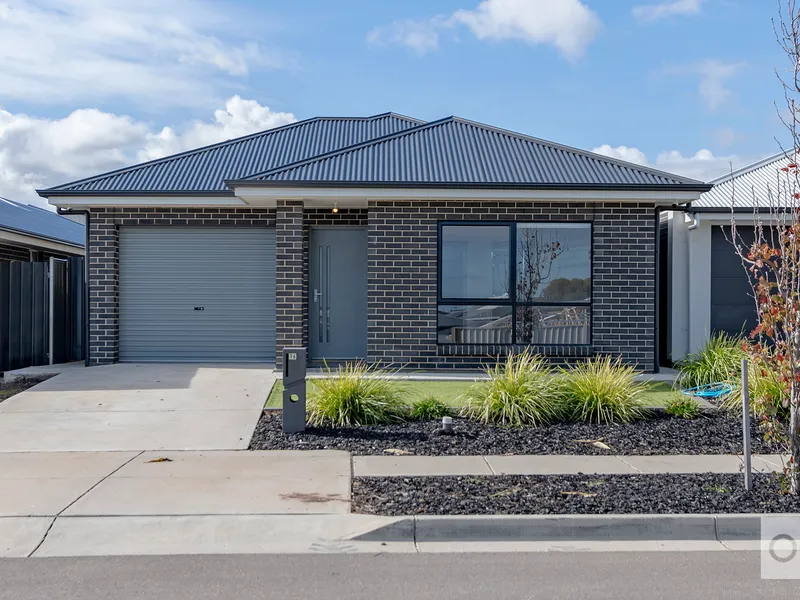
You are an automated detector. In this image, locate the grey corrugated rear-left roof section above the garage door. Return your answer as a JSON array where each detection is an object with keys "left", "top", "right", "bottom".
[{"left": 39, "top": 113, "right": 424, "bottom": 197}]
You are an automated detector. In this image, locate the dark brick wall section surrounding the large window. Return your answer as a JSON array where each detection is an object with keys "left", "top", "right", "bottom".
[{"left": 368, "top": 201, "right": 655, "bottom": 370}]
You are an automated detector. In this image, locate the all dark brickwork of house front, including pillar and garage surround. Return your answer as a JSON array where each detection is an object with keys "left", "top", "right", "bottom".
[{"left": 83, "top": 200, "right": 655, "bottom": 370}]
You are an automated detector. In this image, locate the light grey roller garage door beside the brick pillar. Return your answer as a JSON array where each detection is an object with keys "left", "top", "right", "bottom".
[{"left": 119, "top": 227, "right": 275, "bottom": 362}]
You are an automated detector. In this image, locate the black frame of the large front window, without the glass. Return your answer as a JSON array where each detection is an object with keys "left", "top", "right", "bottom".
[{"left": 436, "top": 220, "right": 594, "bottom": 347}]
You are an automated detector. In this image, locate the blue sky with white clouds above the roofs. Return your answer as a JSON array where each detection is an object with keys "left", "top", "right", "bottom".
[{"left": 0, "top": 0, "right": 785, "bottom": 206}]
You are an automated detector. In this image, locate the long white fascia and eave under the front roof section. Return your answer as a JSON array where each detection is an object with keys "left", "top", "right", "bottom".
[{"left": 233, "top": 186, "right": 701, "bottom": 206}]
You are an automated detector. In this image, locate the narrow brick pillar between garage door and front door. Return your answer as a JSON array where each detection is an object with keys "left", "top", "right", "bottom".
[{"left": 275, "top": 200, "right": 305, "bottom": 368}]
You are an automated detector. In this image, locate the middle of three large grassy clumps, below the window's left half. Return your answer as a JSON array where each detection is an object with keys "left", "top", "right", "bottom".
[{"left": 460, "top": 350, "right": 562, "bottom": 427}]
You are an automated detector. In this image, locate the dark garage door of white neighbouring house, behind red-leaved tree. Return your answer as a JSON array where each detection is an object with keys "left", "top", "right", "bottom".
[{"left": 711, "top": 227, "right": 756, "bottom": 335}]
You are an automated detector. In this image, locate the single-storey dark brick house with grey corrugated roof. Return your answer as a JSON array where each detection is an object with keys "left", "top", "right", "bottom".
[{"left": 39, "top": 113, "right": 710, "bottom": 370}]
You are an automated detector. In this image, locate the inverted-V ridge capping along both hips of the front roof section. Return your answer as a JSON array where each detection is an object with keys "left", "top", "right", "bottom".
[{"left": 239, "top": 115, "right": 704, "bottom": 185}]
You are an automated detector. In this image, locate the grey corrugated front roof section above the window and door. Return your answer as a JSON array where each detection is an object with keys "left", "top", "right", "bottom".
[{"left": 236, "top": 117, "right": 709, "bottom": 191}]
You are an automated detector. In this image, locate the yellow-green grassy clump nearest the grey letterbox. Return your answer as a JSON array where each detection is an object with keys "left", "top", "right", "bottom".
[{"left": 308, "top": 362, "right": 407, "bottom": 427}]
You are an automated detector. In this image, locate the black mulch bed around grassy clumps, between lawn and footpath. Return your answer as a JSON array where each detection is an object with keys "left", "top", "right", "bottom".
[{"left": 250, "top": 410, "right": 779, "bottom": 455}]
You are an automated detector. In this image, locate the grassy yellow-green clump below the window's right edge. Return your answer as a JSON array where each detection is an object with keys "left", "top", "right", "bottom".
[{"left": 561, "top": 356, "right": 647, "bottom": 423}]
